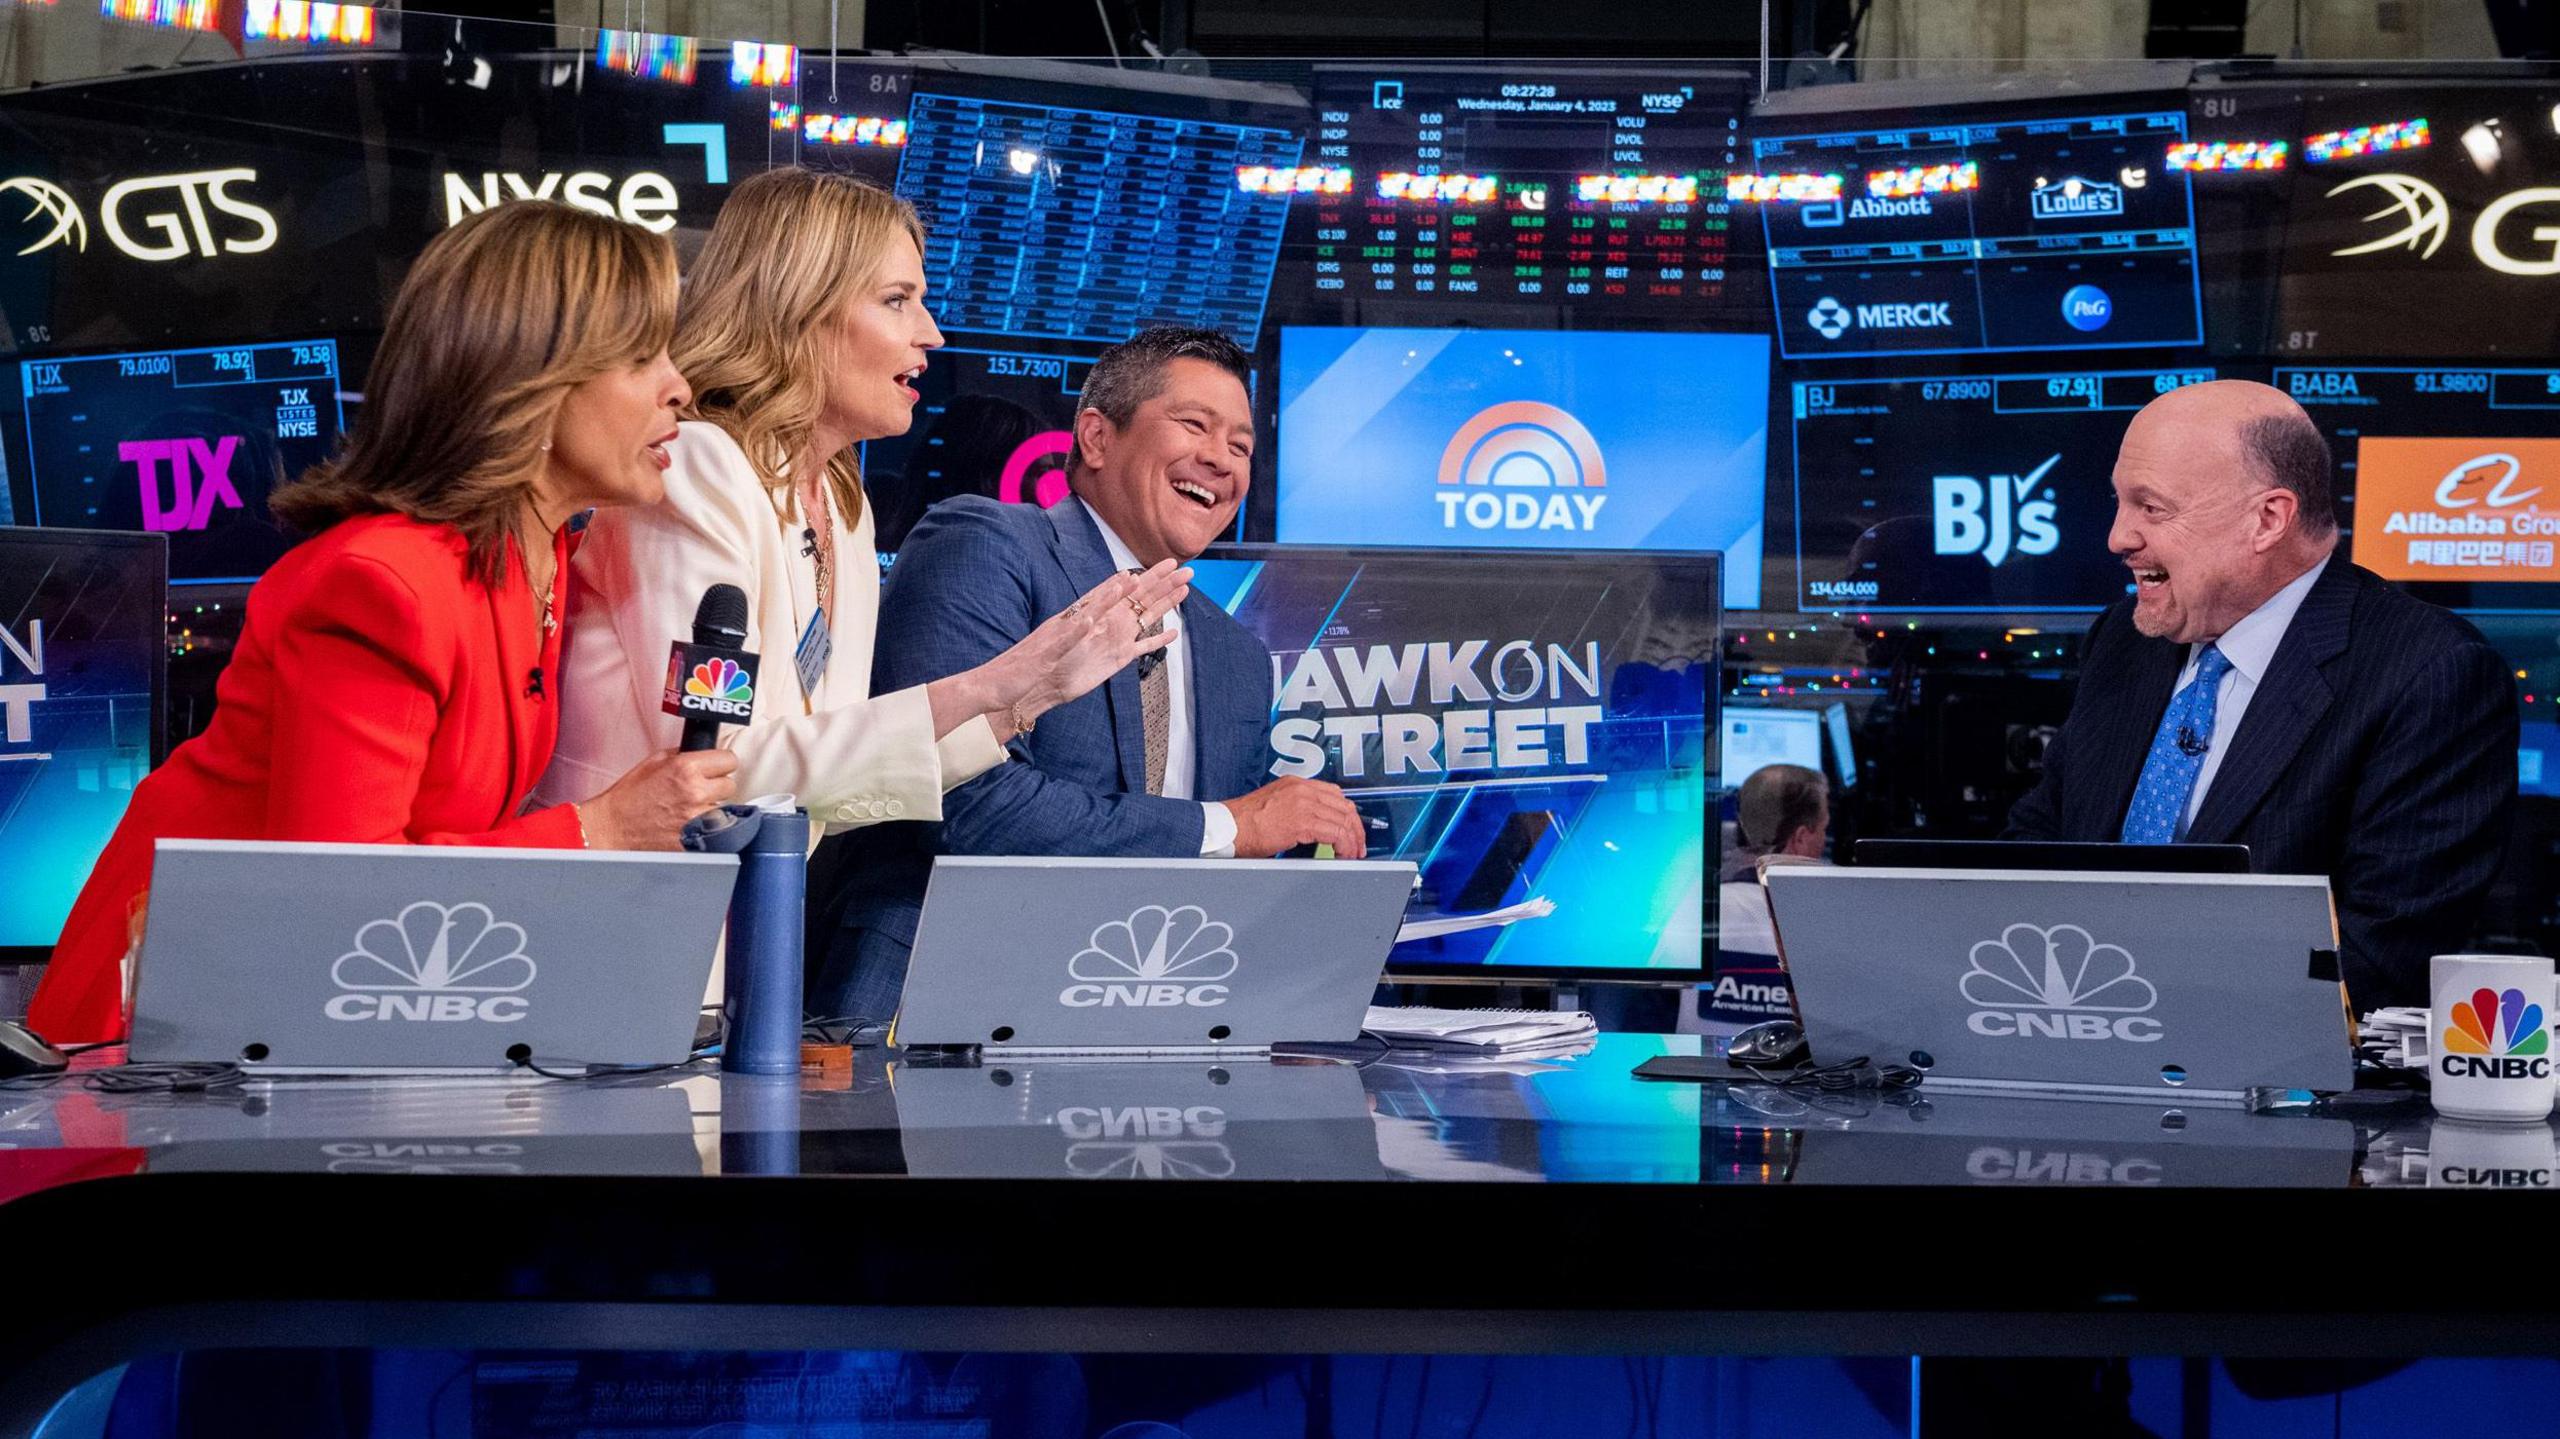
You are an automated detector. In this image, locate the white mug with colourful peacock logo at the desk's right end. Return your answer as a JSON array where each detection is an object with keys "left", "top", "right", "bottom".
[{"left": 2427, "top": 955, "right": 2552, "bottom": 1124}]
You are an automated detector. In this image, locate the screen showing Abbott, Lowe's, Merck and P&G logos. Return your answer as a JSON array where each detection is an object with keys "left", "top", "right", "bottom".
[{"left": 1738, "top": 108, "right": 2204, "bottom": 358}]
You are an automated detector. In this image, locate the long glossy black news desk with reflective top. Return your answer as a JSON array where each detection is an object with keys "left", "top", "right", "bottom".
[{"left": 0, "top": 1034, "right": 2560, "bottom": 1431}]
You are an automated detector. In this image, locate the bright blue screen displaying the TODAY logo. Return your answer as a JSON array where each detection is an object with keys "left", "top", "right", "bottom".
[{"left": 1277, "top": 328, "right": 1769, "bottom": 609}]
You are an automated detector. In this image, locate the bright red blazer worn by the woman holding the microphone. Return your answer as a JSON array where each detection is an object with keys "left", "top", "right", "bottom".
[{"left": 28, "top": 515, "right": 584, "bottom": 1045}]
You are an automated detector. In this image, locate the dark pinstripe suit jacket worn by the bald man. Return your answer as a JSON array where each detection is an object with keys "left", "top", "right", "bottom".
[{"left": 2010, "top": 556, "right": 2516, "bottom": 1011}]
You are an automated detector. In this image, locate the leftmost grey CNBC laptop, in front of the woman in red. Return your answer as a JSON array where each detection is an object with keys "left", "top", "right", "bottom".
[{"left": 128, "top": 840, "right": 737, "bottom": 1073}]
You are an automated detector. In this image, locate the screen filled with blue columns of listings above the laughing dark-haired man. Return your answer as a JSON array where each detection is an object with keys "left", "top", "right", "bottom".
[{"left": 899, "top": 82, "right": 1303, "bottom": 348}]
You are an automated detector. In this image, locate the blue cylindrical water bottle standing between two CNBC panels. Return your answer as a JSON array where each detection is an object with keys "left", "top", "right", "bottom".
[{"left": 719, "top": 809, "right": 809, "bottom": 1075}]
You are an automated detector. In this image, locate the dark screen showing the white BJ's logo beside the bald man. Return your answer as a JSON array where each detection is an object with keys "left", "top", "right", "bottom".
[{"left": 1789, "top": 369, "right": 2214, "bottom": 612}]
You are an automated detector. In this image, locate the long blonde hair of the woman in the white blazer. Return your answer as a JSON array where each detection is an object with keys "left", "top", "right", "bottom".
[{"left": 673, "top": 166, "right": 924, "bottom": 525}]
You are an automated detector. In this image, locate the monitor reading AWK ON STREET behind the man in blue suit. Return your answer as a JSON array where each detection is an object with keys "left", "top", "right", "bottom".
[{"left": 1193, "top": 545, "right": 1720, "bottom": 983}]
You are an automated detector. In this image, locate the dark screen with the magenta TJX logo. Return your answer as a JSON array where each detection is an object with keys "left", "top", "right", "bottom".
[{"left": 18, "top": 341, "right": 343, "bottom": 584}]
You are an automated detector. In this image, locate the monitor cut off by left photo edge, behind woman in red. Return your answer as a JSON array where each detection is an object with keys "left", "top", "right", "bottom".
[{"left": 0, "top": 527, "right": 169, "bottom": 963}]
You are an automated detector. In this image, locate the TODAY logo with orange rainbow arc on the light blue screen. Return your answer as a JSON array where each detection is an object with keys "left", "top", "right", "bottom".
[{"left": 1436, "top": 399, "right": 1608, "bottom": 533}]
